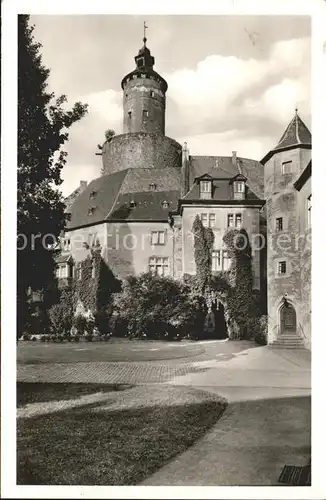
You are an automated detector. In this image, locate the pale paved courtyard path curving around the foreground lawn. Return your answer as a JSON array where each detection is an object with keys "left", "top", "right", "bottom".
[{"left": 17, "top": 342, "right": 310, "bottom": 486}]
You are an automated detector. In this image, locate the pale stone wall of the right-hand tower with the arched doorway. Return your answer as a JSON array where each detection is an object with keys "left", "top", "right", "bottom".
[{"left": 265, "top": 148, "right": 308, "bottom": 342}]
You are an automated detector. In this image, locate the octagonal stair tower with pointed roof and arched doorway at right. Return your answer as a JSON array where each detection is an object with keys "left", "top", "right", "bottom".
[{"left": 261, "top": 109, "right": 311, "bottom": 342}]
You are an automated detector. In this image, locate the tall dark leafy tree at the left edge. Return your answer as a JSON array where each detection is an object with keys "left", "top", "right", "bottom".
[{"left": 17, "top": 15, "right": 87, "bottom": 334}]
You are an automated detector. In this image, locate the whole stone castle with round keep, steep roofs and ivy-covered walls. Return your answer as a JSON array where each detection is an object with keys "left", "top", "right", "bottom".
[{"left": 57, "top": 37, "right": 311, "bottom": 348}]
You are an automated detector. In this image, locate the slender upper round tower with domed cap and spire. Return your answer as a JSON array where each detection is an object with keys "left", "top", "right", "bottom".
[{"left": 121, "top": 23, "right": 168, "bottom": 135}]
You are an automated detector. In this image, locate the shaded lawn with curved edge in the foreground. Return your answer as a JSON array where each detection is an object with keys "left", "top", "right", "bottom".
[{"left": 17, "top": 384, "right": 225, "bottom": 486}]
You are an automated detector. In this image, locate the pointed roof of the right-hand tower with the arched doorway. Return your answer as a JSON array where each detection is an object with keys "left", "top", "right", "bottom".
[{"left": 261, "top": 111, "right": 311, "bottom": 164}]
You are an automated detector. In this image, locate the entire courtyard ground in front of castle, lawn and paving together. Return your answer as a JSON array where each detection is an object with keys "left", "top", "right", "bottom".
[{"left": 17, "top": 340, "right": 310, "bottom": 485}]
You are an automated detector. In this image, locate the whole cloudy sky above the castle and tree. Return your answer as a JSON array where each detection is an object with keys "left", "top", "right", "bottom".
[{"left": 31, "top": 15, "right": 311, "bottom": 196}]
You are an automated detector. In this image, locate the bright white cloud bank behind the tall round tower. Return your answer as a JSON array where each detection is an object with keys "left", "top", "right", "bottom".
[{"left": 63, "top": 34, "right": 310, "bottom": 194}]
